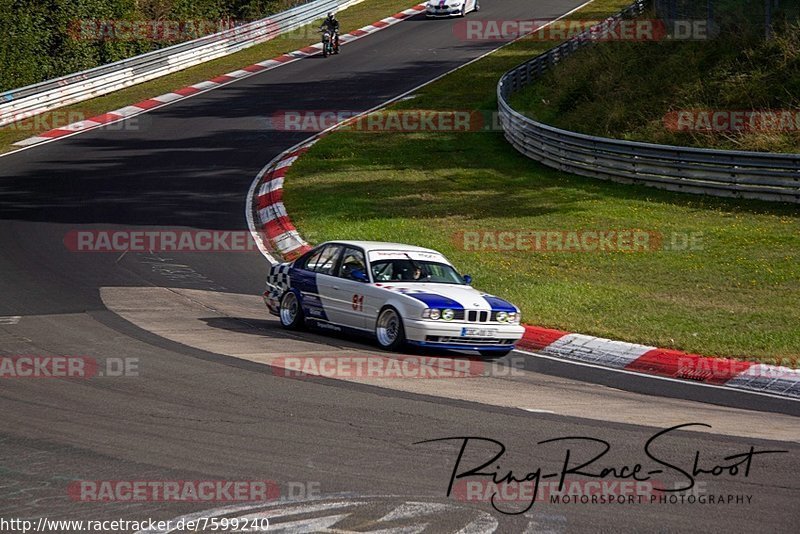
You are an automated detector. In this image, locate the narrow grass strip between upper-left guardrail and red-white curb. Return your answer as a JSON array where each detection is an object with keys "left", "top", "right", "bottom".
[{"left": 0, "top": 0, "right": 418, "bottom": 153}]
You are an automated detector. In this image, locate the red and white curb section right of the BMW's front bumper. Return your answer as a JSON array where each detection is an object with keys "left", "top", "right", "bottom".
[{"left": 517, "top": 325, "right": 800, "bottom": 400}]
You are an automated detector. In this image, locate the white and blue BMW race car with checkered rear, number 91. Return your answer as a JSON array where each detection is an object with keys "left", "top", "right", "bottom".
[{"left": 264, "top": 241, "right": 524, "bottom": 357}]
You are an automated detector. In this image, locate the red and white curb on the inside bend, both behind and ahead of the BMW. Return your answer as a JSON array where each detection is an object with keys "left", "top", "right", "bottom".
[{"left": 249, "top": 144, "right": 800, "bottom": 400}]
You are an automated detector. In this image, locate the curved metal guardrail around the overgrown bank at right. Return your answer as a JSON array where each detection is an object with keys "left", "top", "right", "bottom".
[{"left": 497, "top": 0, "right": 800, "bottom": 203}]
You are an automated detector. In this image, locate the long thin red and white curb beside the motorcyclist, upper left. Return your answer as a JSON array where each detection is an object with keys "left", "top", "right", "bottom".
[{"left": 14, "top": 4, "right": 425, "bottom": 151}]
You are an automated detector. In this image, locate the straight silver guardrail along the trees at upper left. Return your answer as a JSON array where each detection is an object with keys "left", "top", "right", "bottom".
[{"left": 0, "top": 0, "right": 354, "bottom": 126}]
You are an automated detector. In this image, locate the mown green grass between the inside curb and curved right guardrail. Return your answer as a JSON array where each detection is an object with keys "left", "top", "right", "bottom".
[{"left": 284, "top": 1, "right": 800, "bottom": 360}]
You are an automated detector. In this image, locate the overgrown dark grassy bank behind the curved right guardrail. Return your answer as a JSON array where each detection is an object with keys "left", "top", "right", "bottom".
[{"left": 511, "top": 8, "right": 800, "bottom": 153}]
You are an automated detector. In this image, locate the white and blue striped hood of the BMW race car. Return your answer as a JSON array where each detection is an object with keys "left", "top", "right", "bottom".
[{"left": 375, "top": 282, "right": 517, "bottom": 312}]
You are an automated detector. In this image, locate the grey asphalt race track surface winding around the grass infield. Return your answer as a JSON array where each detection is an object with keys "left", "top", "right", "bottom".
[{"left": 0, "top": 0, "right": 800, "bottom": 532}]
